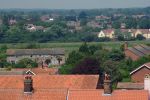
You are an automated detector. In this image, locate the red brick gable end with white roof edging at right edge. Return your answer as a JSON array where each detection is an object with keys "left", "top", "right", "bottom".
[{"left": 130, "top": 62, "right": 150, "bottom": 83}]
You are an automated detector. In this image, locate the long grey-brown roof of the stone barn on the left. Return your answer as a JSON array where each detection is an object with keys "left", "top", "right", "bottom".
[{"left": 6, "top": 48, "right": 65, "bottom": 56}]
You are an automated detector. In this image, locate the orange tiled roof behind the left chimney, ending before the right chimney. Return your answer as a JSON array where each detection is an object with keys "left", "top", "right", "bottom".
[{"left": 0, "top": 75, "right": 99, "bottom": 89}]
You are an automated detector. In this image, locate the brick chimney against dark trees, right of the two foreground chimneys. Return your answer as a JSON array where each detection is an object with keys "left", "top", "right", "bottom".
[{"left": 104, "top": 73, "right": 112, "bottom": 95}]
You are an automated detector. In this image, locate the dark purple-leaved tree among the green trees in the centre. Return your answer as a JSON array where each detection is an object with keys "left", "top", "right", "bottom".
[{"left": 72, "top": 57, "right": 101, "bottom": 74}]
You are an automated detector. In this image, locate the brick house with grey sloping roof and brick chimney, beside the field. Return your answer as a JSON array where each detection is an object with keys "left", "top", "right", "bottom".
[{"left": 124, "top": 42, "right": 150, "bottom": 61}]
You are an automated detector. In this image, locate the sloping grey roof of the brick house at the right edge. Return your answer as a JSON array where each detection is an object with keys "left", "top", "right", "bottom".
[{"left": 128, "top": 44, "right": 150, "bottom": 56}]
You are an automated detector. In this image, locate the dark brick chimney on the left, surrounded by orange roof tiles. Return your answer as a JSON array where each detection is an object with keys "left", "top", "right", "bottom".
[{"left": 24, "top": 76, "right": 33, "bottom": 93}]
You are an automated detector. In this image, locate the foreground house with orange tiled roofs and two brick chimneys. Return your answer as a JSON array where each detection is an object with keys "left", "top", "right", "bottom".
[{"left": 0, "top": 75, "right": 148, "bottom": 100}]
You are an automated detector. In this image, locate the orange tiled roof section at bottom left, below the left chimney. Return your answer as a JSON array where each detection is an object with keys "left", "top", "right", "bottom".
[{"left": 0, "top": 89, "right": 67, "bottom": 100}]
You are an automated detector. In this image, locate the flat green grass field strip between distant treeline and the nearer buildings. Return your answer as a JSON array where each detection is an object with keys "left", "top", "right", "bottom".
[{"left": 0, "top": 40, "right": 150, "bottom": 54}]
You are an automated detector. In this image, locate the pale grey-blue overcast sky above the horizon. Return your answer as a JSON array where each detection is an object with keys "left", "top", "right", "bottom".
[{"left": 0, "top": 0, "right": 150, "bottom": 9}]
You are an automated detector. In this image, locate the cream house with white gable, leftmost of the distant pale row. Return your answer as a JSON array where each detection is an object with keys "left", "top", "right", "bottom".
[{"left": 98, "top": 29, "right": 115, "bottom": 39}]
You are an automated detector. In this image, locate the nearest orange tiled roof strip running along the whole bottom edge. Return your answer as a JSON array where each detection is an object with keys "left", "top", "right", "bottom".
[{"left": 0, "top": 89, "right": 148, "bottom": 100}]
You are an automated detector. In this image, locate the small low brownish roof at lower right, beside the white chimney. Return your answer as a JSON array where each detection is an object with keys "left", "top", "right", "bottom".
[{"left": 117, "top": 82, "right": 144, "bottom": 90}]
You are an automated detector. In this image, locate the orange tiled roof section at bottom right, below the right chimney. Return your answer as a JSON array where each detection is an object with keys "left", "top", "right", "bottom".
[{"left": 69, "top": 90, "right": 148, "bottom": 100}]
